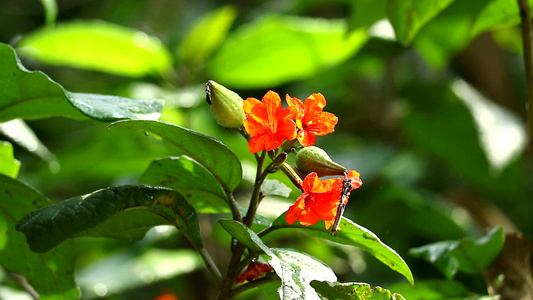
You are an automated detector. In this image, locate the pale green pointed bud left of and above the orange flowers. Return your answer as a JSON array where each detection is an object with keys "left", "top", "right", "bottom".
[{"left": 205, "top": 80, "right": 245, "bottom": 128}]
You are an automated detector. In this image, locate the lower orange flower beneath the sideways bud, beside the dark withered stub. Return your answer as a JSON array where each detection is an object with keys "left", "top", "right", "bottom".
[{"left": 285, "top": 171, "right": 362, "bottom": 229}]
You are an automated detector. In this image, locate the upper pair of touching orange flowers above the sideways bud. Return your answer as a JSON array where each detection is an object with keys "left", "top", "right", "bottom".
[{"left": 243, "top": 91, "right": 338, "bottom": 153}]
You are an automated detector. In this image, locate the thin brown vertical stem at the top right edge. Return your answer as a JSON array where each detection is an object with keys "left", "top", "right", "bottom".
[{"left": 517, "top": 0, "right": 533, "bottom": 167}]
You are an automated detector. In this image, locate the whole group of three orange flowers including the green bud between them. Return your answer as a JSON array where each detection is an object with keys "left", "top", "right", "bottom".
[{"left": 243, "top": 91, "right": 362, "bottom": 230}]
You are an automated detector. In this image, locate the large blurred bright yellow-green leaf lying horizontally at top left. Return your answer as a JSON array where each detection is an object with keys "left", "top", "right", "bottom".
[{"left": 18, "top": 21, "right": 172, "bottom": 77}]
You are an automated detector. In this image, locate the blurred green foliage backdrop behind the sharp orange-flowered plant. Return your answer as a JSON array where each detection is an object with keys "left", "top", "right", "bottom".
[{"left": 0, "top": 0, "right": 533, "bottom": 300}]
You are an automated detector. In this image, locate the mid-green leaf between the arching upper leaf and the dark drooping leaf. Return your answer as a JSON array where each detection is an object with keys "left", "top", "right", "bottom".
[{"left": 139, "top": 155, "right": 229, "bottom": 213}]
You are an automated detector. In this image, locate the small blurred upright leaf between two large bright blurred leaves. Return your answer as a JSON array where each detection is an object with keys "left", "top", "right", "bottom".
[{"left": 177, "top": 5, "right": 237, "bottom": 64}]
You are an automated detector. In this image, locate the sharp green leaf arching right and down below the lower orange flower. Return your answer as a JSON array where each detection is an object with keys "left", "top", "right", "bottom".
[{"left": 266, "top": 213, "right": 413, "bottom": 283}]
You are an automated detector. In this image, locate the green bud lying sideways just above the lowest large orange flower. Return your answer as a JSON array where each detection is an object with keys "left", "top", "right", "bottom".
[{"left": 296, "top": 146, "right": 346, "bottom": 177}]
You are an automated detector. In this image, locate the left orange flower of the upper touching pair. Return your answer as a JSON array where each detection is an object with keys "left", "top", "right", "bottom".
[{"left": 244, "top": 91, "right": 296, "bottom": 153}]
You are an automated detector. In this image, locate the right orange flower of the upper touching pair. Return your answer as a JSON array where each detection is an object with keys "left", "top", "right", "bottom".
[{"left": 285, "top": 93, "right": 338, "bottom": 147}]
